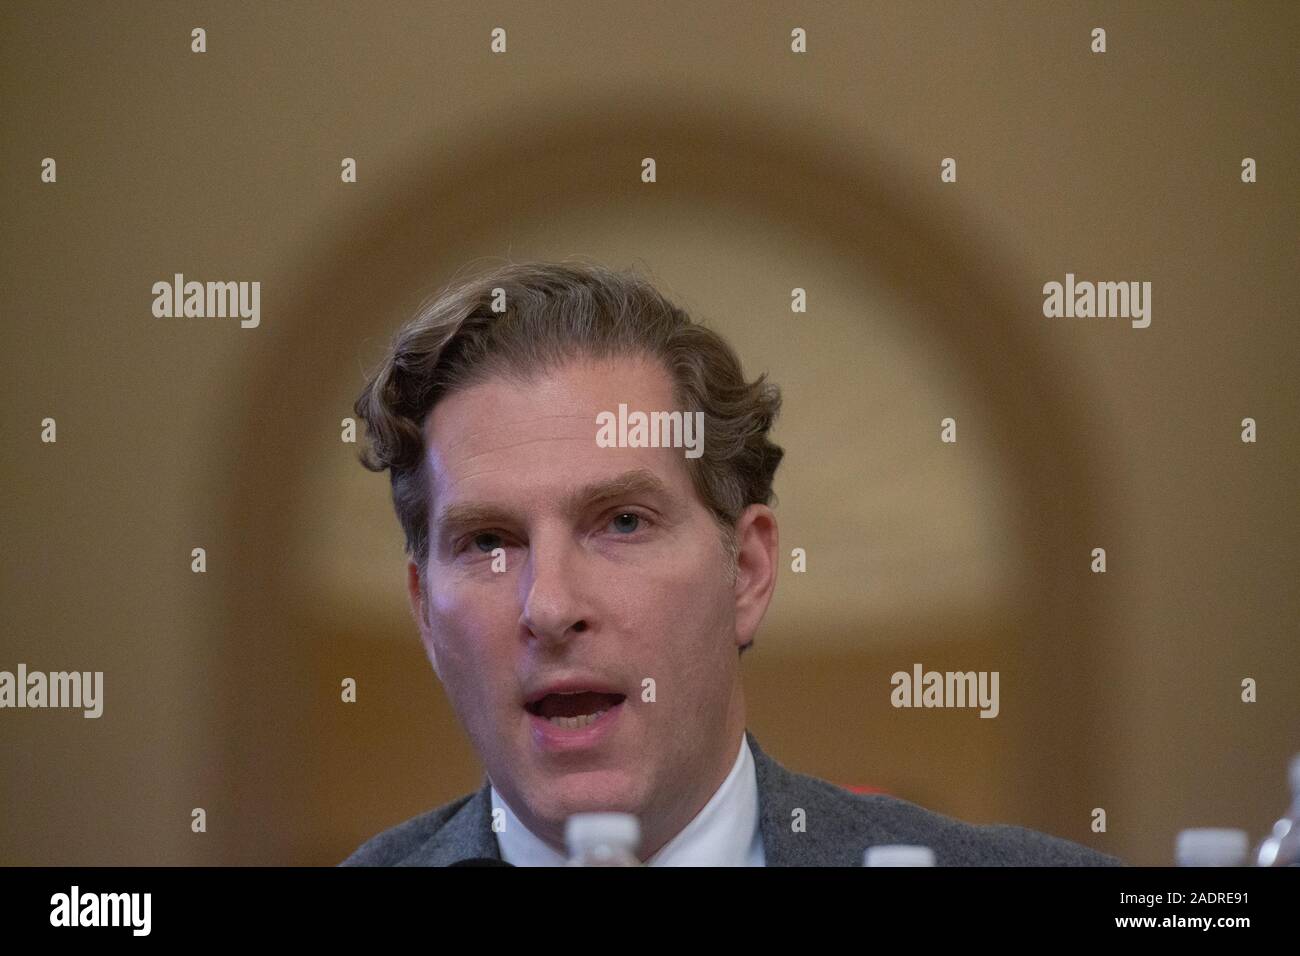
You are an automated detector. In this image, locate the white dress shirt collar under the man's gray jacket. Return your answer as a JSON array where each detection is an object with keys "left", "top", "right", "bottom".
[{"left": 491, "top": 734, "right": 766, "bottom": 866}]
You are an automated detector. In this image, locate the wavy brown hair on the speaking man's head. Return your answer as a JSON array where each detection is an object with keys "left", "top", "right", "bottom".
[{"left": 354, "top": 261, "right": 784, "bottom": 606}]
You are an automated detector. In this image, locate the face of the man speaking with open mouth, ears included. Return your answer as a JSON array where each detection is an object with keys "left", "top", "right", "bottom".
[{"left": 408, "top": 359, "right": 776, "bottom": 851}]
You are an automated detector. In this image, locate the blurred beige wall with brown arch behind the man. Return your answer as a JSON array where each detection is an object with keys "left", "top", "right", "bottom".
[{"left": 0, "top": 4, "right": 1300, "bottom": 864}]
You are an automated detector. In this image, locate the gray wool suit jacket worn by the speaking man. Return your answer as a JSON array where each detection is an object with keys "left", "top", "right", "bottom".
[{"left": 339, "top": 730, "right": 1122, "bottom": 866}]
